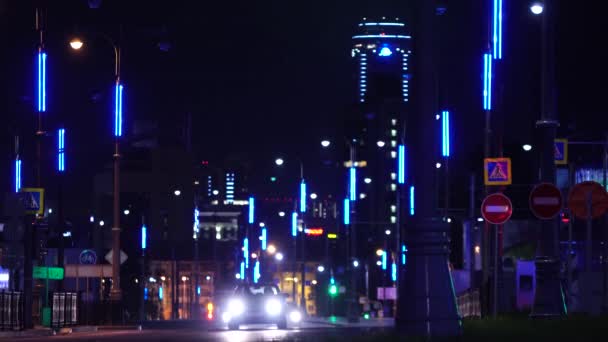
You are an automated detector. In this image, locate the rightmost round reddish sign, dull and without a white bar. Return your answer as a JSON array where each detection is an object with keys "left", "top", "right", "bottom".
[{"left": 568, "top": 181, "right": 608, "bottom": 219}]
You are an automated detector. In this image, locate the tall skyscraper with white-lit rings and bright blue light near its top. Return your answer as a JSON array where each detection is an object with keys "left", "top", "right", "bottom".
[{"left": 351, "top": 18, "right": 411, "bottom": 272}]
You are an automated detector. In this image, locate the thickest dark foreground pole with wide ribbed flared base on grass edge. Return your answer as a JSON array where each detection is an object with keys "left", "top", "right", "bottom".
[{"left": 395, "top": 0, "right": 461, "bottom": 338}]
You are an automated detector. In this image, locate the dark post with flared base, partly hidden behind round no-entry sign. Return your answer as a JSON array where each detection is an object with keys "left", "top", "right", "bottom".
[{"left": 530, "top": 0, "right": 566, "bottom": 318}]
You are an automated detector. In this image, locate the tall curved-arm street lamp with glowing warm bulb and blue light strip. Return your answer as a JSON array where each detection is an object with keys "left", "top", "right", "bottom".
[{"left": 70, "top": 30, "right": 123, "bottom": 301}]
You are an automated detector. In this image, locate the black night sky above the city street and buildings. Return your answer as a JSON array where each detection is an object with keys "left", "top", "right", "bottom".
[{"left": 0, "top": 0, "right": 607, "bottom": 208}]
